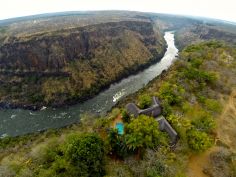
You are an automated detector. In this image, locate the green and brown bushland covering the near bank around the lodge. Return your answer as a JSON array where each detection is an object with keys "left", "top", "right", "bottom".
[{"left": 0, "top": 42, "right": 236, "bottom": 177}]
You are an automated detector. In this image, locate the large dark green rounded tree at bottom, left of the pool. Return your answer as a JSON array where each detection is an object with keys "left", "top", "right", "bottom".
[{"left": 65, "top": 134, "right": 105, "bottom": 177}]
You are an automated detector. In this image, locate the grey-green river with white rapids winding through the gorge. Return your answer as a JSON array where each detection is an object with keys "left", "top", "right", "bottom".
[{"left": 0, "top": 32, "right": 178, "bottom": 137}]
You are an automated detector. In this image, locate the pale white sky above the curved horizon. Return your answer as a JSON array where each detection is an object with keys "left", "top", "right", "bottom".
[{"left": 0, "top": 0, "right": 236, "bottom": 22}]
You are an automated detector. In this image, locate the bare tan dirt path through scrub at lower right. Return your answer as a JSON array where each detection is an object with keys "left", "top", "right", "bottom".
[{"left": 187, "top": 89, "right": 236, "bottom": 177}]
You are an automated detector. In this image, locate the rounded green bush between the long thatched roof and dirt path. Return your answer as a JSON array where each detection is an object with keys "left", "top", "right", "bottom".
[{"left": 187, "top": 129, "right": 213, "bottom": 152}]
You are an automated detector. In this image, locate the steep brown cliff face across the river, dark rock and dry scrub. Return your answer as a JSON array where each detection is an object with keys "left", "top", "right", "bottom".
[{"left": 0, "top": 21, "right": 165, "bottom": 106}]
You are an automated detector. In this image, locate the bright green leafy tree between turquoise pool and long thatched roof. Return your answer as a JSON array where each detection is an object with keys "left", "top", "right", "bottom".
[{"left": 125, "top": 115, "right": 161, "bottom": 150}]
